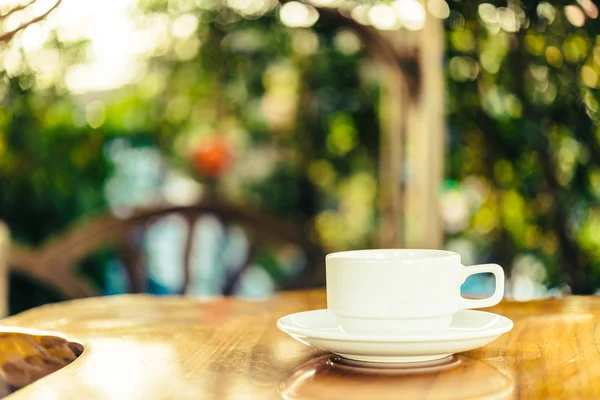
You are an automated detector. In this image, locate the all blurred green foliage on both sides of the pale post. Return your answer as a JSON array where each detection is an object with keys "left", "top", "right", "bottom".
[{"left": 0, "top": 0, "right": 600, "bottom": 293}]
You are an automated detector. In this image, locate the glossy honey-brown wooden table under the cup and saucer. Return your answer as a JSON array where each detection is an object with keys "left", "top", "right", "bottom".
[{"left": 0, "top": 290, "right": 600, "bottom": 400}]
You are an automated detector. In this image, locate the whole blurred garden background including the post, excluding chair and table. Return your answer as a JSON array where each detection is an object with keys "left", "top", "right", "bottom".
[{"left": 0, "top": 0, "right": 600, "bottom": 312}]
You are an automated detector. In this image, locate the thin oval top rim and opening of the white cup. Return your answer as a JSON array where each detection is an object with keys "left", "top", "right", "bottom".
[{"left": 325, "top": 249, "right": 460, "bottom": 262}]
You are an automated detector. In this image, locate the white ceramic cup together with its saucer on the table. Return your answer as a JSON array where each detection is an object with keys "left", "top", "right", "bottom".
[{"left": 277, "top": 249, "right": 513, "bottom": 363}]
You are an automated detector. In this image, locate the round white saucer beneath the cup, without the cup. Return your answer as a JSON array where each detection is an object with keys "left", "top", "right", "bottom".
[{"left": 277, "top": 310, "right": 513, "bottom": 363}]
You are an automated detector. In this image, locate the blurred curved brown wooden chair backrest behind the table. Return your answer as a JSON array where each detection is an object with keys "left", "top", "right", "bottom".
[{"left": 9, "top": 203, "right": 325, "bottom": 298}]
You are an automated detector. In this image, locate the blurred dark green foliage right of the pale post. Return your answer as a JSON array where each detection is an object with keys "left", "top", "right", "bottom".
[{"left": 446, "top": 1, "right": 600, "bottom": 293}]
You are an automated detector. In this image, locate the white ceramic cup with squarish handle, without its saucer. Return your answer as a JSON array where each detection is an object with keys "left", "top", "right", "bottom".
[{"left": 326, "top": 249, "right": 504, "bottom": 334}]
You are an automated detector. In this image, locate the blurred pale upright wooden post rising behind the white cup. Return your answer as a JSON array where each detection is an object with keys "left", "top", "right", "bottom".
[{"left": 380, "top": 17, "right": 445, "bottom": 248}]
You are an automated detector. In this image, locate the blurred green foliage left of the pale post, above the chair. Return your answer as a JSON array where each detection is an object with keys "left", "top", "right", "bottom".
[{"left": 0, "top": 1, "right": 379, "bottom": 304}]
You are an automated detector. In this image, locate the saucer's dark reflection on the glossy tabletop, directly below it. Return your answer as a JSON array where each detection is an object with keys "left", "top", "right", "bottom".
[{"left": 279, "top": 355, "right": 514, "bottom": 400}]
